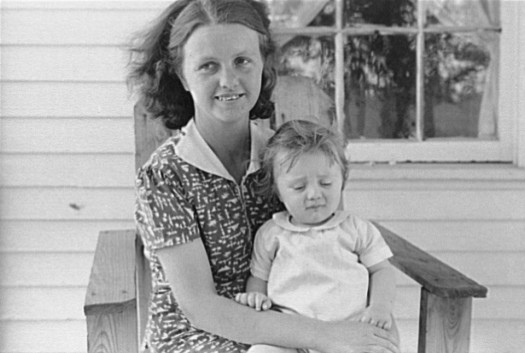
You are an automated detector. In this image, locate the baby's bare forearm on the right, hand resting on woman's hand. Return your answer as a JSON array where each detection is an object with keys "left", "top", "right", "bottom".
[{"left": 360, "top": 260, "right": 396, "bottom": 330}]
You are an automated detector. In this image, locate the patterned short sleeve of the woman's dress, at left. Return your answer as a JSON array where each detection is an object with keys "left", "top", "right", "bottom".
[{"left": 135, "top": 158, "right": 200, "bottom": 250}]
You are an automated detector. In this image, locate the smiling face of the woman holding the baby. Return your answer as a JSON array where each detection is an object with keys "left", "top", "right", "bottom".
[{"left": 181, "top": 24, "right": 263, "bottom": 124}]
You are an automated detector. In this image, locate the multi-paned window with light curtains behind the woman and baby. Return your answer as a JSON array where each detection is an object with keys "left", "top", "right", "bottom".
[{"left": 264, "top": 0, "right": 518, "bottom": 162}]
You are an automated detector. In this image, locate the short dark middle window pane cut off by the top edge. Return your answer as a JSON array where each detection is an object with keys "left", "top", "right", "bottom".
[{"left": 343, "top": 0, "right": 417, "bottom": 27}]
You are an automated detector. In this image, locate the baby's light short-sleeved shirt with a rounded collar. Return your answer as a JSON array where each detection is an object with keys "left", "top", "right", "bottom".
[{"left": 251, "top": 211, "right": 392, "bottom": 321}]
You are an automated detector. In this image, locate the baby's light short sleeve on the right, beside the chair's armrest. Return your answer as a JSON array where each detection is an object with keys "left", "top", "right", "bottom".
[{"left": 353, "top": 217, "right": 393, "bottom": 267}]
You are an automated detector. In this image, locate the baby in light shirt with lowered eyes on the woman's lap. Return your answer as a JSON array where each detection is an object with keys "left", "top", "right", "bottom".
[{"left": 235, "top": 120, "right": 395, "bottom": 352}]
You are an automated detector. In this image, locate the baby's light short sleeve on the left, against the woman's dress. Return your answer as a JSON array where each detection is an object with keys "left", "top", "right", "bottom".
[{"left": 250, "top": 220, "right": 278, "bottom": 281}]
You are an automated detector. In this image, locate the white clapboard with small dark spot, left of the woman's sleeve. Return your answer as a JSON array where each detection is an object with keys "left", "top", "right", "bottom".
[{"left": 0, "top": 188, "right": 135, "bottom": 221}]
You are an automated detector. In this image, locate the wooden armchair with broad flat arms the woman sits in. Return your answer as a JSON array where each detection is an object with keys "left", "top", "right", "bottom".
[{"left": 84, "top": 77, "right": 487, "bottom": 353}]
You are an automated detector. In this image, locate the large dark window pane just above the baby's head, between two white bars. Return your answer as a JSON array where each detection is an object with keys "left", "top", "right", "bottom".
[{"left": 343, "top": 34, "right": 416, "bottom": 139}]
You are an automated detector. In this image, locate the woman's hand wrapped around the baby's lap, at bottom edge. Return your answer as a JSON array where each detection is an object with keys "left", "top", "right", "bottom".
[{"left": 319, "top": 321, "right": 400, "bottom": 353}]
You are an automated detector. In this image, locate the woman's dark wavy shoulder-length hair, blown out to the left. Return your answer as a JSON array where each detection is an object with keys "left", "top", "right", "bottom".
[{"left": 127, "top": 0, "right": 276, "bottom": 129}]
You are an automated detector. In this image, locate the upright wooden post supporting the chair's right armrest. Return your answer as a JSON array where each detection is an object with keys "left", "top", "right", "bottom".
[{"left": 418, "top": 288, "right": 472, "bottom": 353}]
